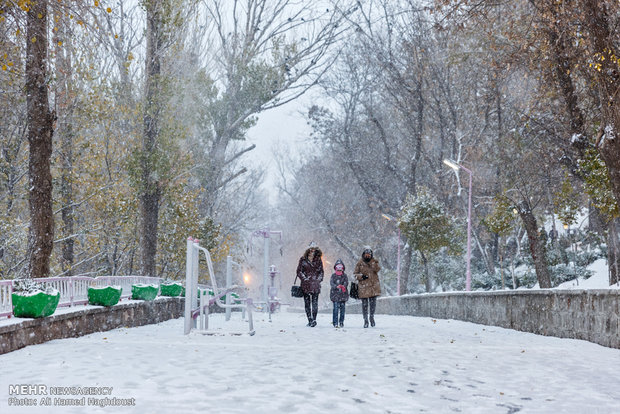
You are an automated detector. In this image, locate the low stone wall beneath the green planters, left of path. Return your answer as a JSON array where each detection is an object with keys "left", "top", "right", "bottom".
[{"left": 0, "top": 298, "right": 188, "bottom": 354}]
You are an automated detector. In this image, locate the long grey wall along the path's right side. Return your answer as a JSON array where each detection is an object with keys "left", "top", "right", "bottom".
[{"left": 347, "top": 290, "right": 620, "bottom": 349}]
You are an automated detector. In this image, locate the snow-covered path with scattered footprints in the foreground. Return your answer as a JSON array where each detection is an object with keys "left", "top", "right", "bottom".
[{"left": 0, "top": 312, "right": 620, "bottom": 414}]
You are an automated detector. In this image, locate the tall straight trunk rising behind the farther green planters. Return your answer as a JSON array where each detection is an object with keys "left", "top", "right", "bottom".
[{"left": 140, "top": 2, "right": 162, "bottom": 276}]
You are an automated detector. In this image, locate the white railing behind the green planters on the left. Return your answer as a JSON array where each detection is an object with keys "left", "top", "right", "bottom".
[{"left": 0, "top": 276, "right": 166, "bottom": 318}]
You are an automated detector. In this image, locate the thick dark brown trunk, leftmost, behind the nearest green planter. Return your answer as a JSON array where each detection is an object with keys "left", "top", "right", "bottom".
[{"left": 25, "top": 1, "right": 54, "bottom": 277}]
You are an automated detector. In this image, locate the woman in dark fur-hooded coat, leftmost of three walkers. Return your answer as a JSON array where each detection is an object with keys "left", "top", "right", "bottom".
[{"left": 297, "top": 242, "right": 323, "bottom": 327}]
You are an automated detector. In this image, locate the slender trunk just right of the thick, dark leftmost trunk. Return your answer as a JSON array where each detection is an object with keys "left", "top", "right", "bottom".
[{"left": 54, "top": 12, "right": 75, "bottom": 276}]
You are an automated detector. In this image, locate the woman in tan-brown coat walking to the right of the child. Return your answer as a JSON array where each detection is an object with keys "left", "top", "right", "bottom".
[{"left": 353, "top": 247, "right": 381, "bottom": 328}]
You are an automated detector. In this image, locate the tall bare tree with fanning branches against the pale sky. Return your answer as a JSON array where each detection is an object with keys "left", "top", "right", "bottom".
[{"left": 193, "top": 0, "right": 344, "bottom": 215}]
